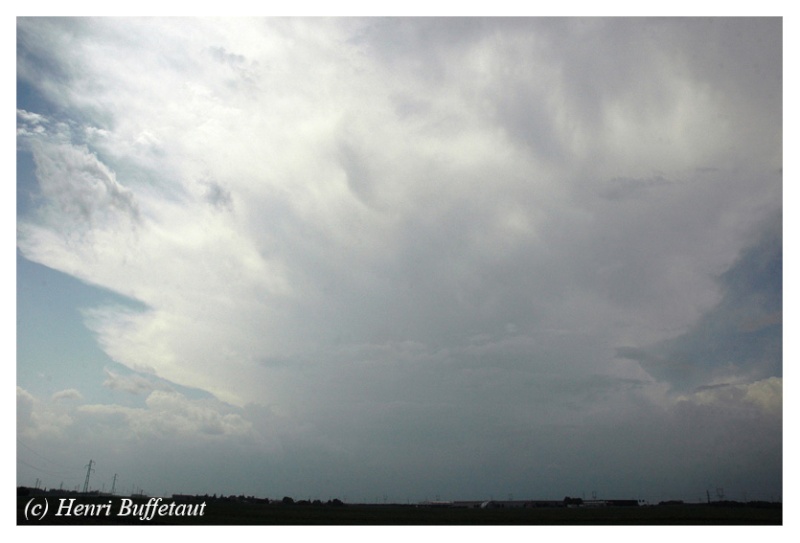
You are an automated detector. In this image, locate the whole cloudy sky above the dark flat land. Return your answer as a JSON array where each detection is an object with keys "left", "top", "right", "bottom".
[{"left": 16, "top": 17, "right": 783, "bottom": 503}]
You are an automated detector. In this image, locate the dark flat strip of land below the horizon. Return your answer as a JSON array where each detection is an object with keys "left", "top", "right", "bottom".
[{"left": 17, "top": 496, "right": 783, "bottom": 526}]
